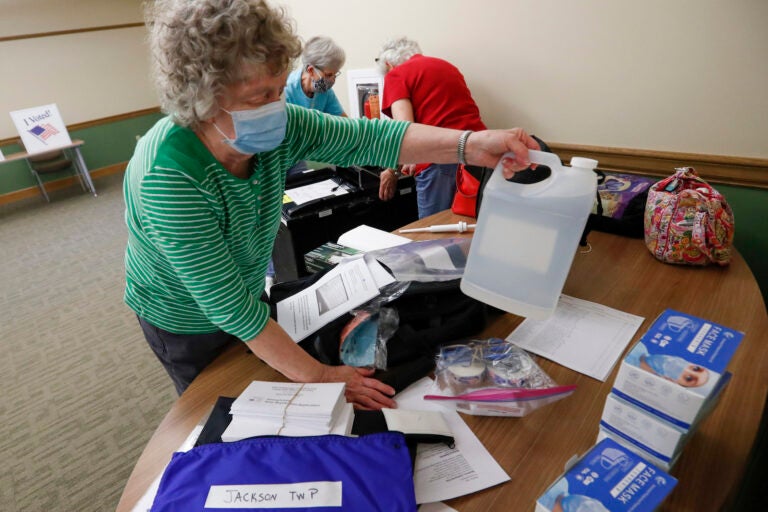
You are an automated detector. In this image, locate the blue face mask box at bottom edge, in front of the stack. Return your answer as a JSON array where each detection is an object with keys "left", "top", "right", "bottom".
[{"left": 535, "top": 439, "right": 677, "bottom": 512}]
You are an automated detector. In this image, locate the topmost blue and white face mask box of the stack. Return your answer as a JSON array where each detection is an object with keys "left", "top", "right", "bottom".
[{"left": 612, "top": 309, "right": 744, "bottom": 429}]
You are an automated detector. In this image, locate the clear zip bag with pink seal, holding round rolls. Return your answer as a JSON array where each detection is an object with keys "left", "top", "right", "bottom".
[{"left": 424, "top": 338, "right": 576, "bottom": 417}]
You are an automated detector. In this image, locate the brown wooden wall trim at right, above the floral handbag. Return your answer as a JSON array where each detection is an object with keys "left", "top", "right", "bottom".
[{"left": 549, "top": 142, "right": 768, "bottom": 189}]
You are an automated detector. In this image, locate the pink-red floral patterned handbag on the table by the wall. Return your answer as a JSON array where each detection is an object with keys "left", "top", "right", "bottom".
[{"left": 644, "top": 167, "right": 735, "bottom": 266}]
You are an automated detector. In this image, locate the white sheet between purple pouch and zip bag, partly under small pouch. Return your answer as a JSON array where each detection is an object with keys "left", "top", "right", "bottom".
[{"left": 395, "top": 377, "right": 509, "bottom": 503}]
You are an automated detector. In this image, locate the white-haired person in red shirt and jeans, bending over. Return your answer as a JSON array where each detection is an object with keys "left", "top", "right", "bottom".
[{"left": 376, "top": 37, "right": 486, "bottom": 218}]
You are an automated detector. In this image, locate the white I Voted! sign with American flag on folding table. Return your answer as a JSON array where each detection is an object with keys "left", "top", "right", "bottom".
[{"left": 10, "top": 103, "right": 72, "bottom": 154}]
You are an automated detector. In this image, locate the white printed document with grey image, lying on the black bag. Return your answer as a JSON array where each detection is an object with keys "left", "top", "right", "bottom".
[{"left": 277, "top": 258, "right": 379, "bottom": 342}]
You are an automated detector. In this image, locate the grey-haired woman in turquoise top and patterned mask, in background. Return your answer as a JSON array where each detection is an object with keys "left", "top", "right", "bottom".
[{"left": 285, "top": 36, "right": 347, "bottom": 117}]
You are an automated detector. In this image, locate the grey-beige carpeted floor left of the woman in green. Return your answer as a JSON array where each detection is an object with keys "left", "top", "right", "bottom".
[{"left": 0, "top": 175, "right": 176, "bottom": 512}]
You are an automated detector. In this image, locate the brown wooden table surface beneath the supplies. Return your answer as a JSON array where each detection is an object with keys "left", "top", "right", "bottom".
[{"left": 117, "top": 211, "right": 768, "bottom": 512}]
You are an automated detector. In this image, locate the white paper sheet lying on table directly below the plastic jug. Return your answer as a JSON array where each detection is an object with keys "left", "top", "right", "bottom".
[{"left": 507, "top": 295, "right": 645, "bottom": 382}]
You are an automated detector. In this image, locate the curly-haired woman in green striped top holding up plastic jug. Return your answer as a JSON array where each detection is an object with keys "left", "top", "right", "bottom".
[{"left": 124, "top": 0, "right": 536, "bottom": 409}]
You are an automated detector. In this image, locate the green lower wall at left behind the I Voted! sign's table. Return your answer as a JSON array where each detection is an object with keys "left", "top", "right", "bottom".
[{"left": 0, "top": 113, "right": 162, "bottom": 194}]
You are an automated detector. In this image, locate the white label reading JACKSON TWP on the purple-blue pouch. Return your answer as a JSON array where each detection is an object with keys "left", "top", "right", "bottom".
[{"left": 205, "top": 482, "right": 342, "bottom": 509}]
